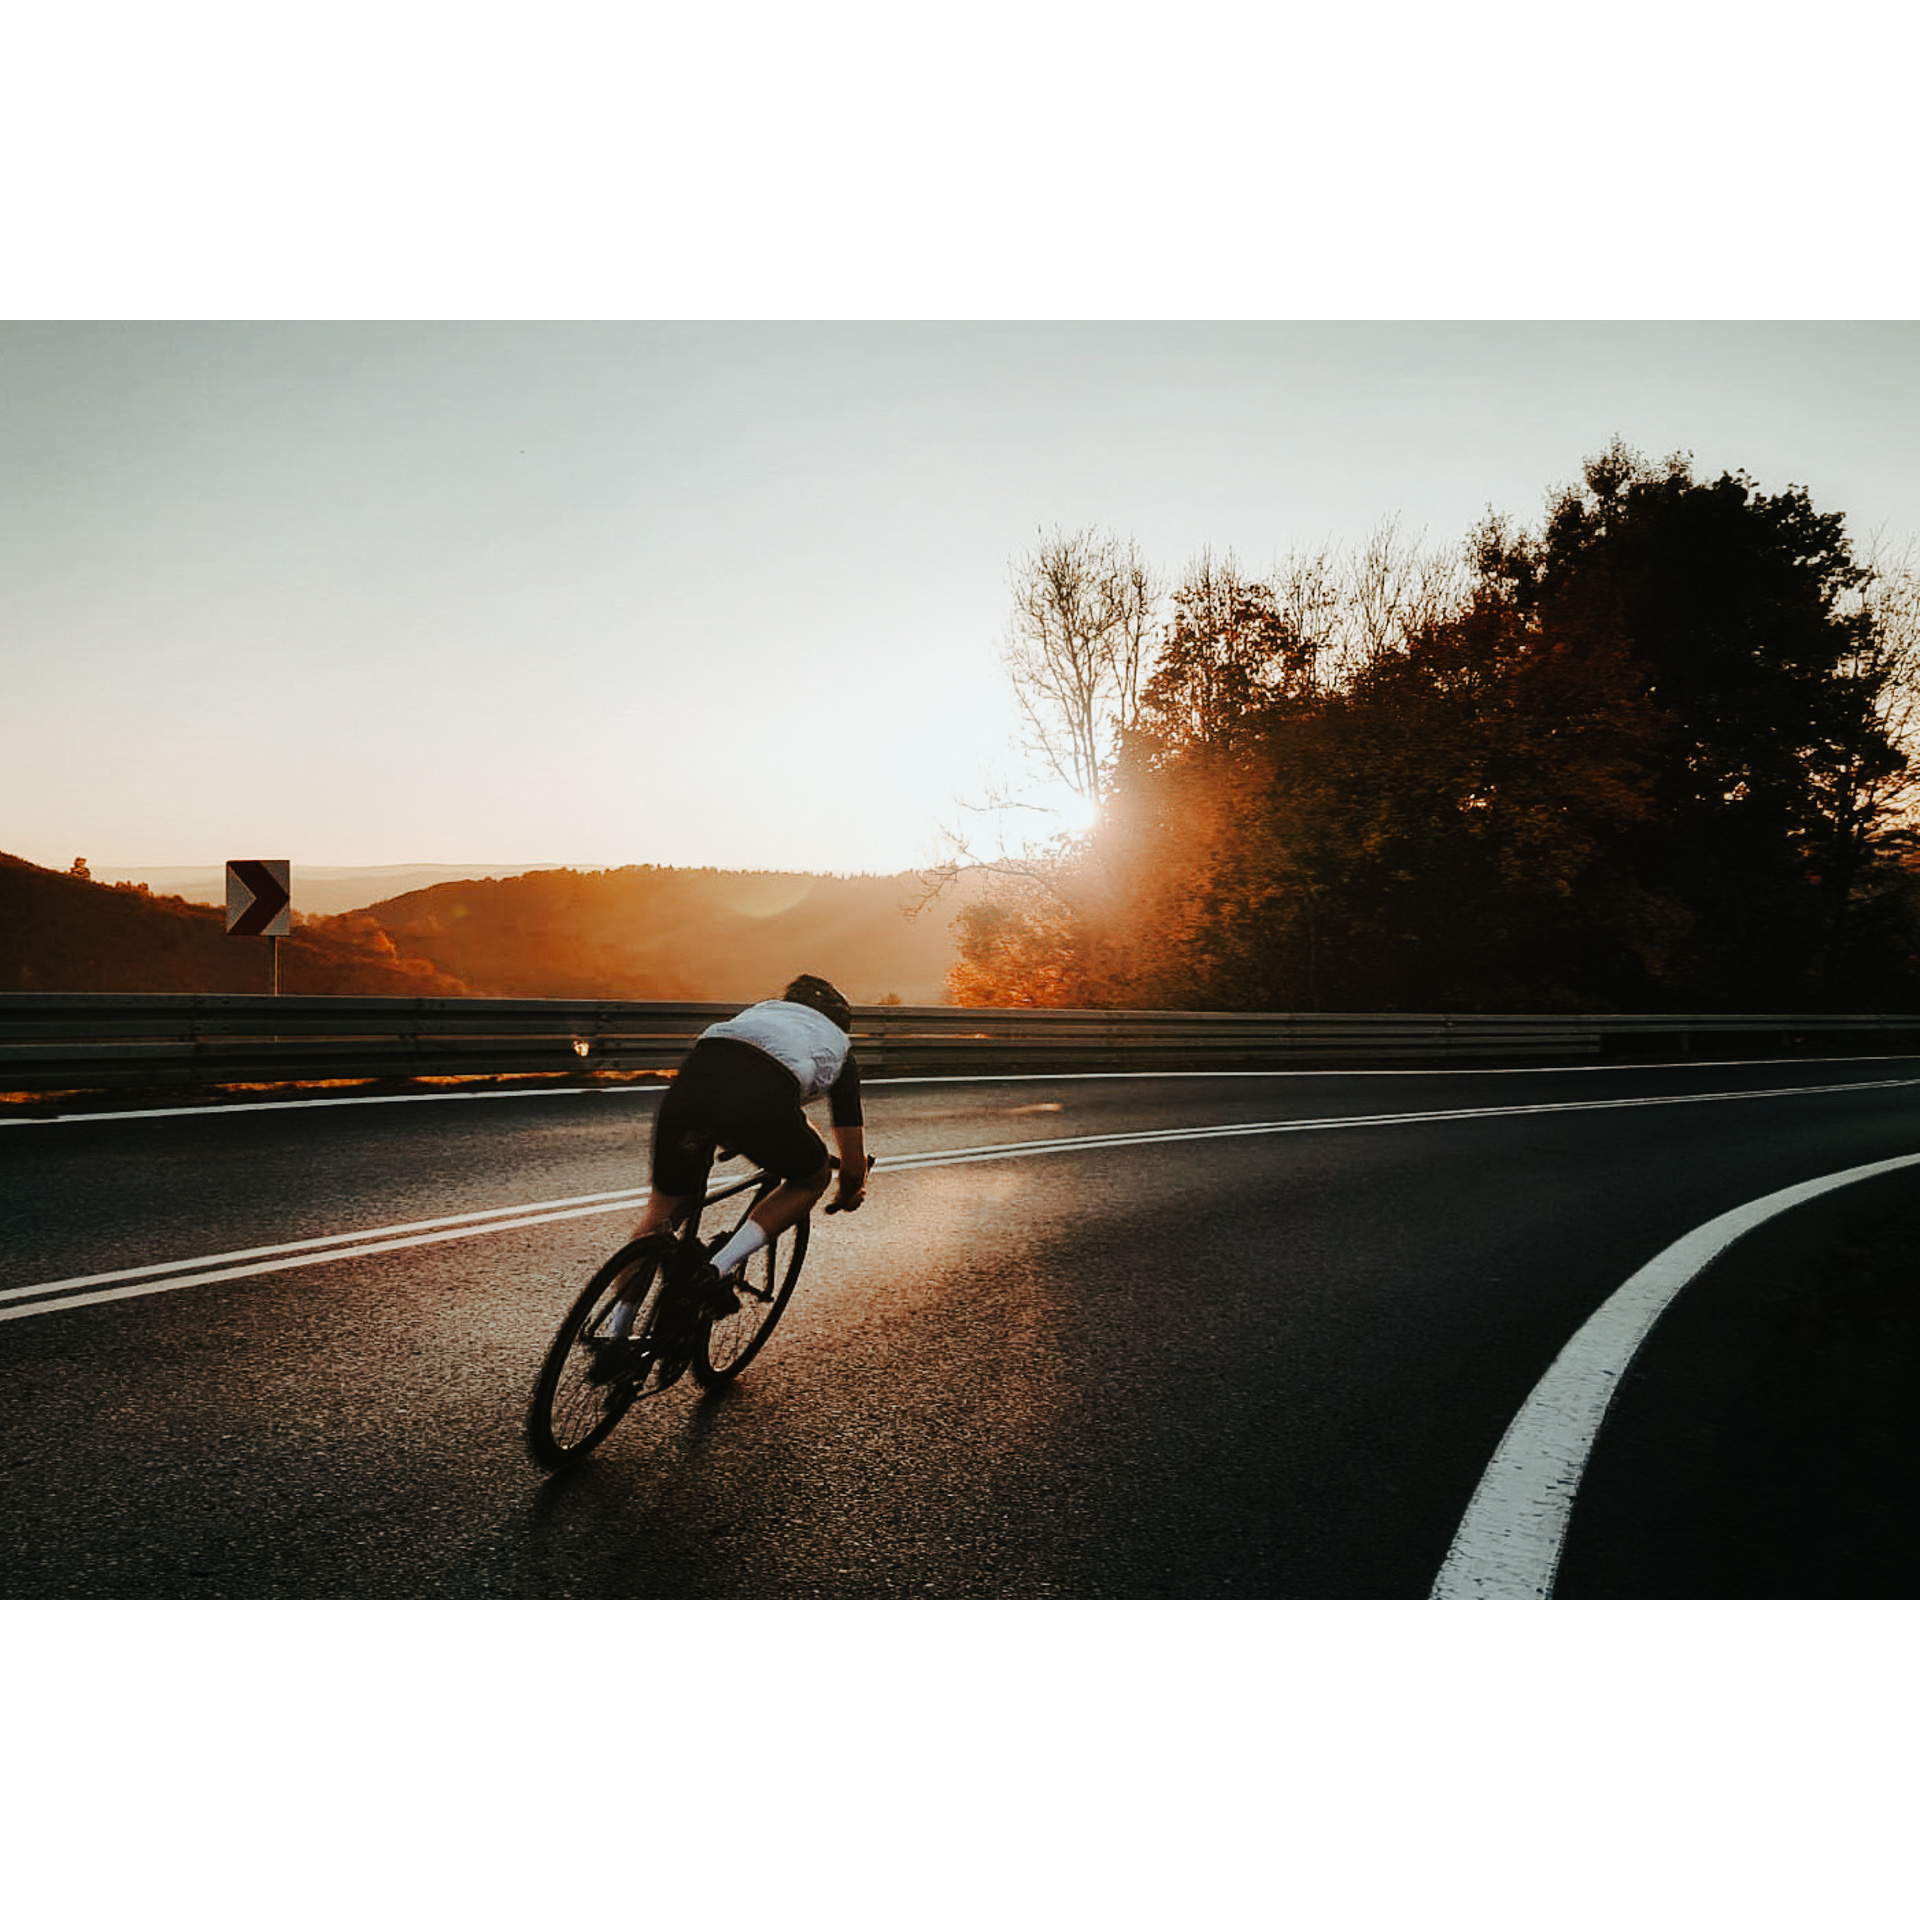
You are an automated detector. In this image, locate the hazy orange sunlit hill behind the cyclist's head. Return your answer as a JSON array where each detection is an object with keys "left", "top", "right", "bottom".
[{"left": 317, "top": 866, "right": 975, "bottom": 1006}]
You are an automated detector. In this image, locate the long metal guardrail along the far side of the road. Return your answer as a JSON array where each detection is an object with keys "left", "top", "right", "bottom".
[{"left": 11, "top": 993, "right": 1920, "bottom": 1092}]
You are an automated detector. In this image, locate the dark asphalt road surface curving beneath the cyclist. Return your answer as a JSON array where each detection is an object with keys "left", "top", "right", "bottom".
[{"left": 0, "top": 1060, "right": 1920, "bottom": 1597}]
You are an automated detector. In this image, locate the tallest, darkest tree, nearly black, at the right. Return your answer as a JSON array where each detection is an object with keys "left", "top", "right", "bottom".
[{"left": 1480, "top": 440, "right": 1907, "bottom": 1006}]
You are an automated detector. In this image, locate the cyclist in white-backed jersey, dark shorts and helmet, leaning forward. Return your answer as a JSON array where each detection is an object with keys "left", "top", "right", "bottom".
[{"left": 603, "top": 973, "right": 866, "bottom": 1342}]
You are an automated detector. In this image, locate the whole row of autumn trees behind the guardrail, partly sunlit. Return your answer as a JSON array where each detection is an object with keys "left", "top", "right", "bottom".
[{"left": 929, "top": 442, "right": 1920, "bottom": 1012}]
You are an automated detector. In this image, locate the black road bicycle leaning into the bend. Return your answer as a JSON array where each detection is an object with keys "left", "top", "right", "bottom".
[{"left": 526, "top": 1146, "right": 856, "bottom": 1473}]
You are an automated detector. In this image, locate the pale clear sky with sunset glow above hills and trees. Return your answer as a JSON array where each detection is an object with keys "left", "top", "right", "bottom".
[{"left": 0, "top": 321, "right": 1920, "bottom": 872}]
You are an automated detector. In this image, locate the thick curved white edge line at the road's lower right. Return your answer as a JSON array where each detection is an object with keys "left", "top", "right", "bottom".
[{"left": 1432, "top": 1154, "right": 1920, "bottom": 1599}]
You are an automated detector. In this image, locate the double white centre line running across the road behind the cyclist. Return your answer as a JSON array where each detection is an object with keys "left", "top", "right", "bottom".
[{"left": 18, "top": 1079, "right": 1920, "bottom": 1321}]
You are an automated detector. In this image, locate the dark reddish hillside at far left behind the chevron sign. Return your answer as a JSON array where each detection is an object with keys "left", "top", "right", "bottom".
[{"left": 0, "top": 852, "right": 468, "bottom": 998}]
